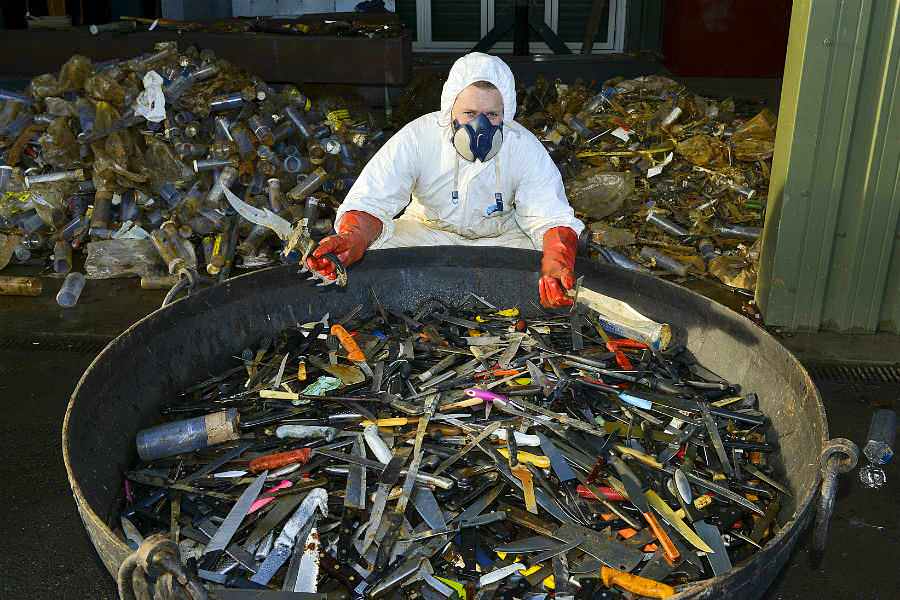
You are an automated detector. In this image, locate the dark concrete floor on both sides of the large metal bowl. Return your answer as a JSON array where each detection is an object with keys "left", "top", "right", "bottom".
[{"left": 0, "top": 267, "right": 900, "bottom": 600}]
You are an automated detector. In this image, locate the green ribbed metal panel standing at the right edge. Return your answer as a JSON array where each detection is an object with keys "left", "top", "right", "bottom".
[{"left": 756, "top": 0, "right": 900, "bottom": 333}]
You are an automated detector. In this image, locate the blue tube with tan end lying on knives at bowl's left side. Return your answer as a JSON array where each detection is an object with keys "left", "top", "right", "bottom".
[{"left": 136, "top": 408, "right": 240, "bottom": 462}]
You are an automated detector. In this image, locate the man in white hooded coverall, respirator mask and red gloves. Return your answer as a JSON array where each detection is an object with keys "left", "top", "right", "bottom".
[{"left": 308, "top": 52, "right": 584, "bottom": 307}]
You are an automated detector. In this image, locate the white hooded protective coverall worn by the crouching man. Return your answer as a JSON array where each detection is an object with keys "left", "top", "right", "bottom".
[{"left": 335, "top": 52, "right": 584, "bottom": 250}]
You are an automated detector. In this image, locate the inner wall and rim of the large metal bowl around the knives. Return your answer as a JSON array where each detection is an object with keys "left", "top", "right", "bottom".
[{"left": 63, "top": 247, "right": 828, "bottom": 598}]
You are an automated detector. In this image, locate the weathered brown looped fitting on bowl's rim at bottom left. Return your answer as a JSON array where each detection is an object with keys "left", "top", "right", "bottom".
[{"left": 116, "top": 534, "right": 208, "bottom": 600}]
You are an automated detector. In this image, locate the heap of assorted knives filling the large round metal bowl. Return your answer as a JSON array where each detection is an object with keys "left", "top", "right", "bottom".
[{"left": 120, "top": 290, "right": 788, "bottom": 598}]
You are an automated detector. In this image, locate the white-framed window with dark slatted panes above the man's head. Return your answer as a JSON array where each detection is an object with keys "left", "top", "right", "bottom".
[{"left": 397, "top": 0, "right": 626, "bottom": 53}]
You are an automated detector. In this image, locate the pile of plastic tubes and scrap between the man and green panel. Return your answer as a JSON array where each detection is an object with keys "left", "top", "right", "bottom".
[{"left": 519, "top": 75, "right": 776, "bottom": 290}]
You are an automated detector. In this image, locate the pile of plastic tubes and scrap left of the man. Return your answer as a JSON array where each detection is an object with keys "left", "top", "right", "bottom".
[{"left": 0, "top": 42, "right": 385, "bottom": 300}]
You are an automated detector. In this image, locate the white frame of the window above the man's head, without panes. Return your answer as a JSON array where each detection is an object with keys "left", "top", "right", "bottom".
[{"left": 413, "top": 0, "right": 628, "bottom": 54}]
